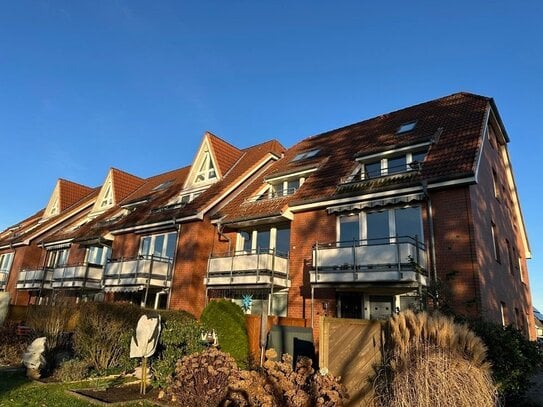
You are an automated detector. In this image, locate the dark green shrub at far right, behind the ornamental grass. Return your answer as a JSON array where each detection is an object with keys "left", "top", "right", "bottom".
[{"left": 469, "top": 320, "right": 542, "bottom": 402}]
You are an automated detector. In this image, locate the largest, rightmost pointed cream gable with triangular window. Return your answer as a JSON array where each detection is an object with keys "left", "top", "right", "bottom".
[{"left": 183, "top": 133, "right": 239, "bottom": 190}]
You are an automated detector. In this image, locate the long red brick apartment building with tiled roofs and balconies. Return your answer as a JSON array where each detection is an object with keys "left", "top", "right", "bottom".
[{"left": 0, "top": 93, "right": 535, "bottom": 338}]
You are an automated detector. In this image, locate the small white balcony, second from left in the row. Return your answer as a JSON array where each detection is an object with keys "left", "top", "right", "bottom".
[{"left": 51, "top": 263, "right": 103, "bottom": 290}]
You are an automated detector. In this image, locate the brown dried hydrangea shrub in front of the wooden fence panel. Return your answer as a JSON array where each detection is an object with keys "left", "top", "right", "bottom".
[{"left": 226, "top": 349, "right": 348, "bottom": 407}]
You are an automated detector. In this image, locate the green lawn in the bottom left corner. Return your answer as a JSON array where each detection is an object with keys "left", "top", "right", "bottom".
[{"left": 0, "top": 372, "right": 152, "bottom": 407}]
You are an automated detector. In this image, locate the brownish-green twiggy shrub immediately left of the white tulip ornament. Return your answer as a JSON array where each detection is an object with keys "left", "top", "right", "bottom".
[{"left": 74, "top": 302, "right": 143, "bottom": 372}]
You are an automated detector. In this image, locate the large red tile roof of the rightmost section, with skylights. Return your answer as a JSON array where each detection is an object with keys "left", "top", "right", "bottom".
[{"left": 217, "top": 93, "right": 491, "bottom": 222}]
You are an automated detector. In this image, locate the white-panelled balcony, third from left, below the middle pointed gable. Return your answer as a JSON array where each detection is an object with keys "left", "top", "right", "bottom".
[{"left": 103, "top": 256, "right": 172, "bottom": 291}]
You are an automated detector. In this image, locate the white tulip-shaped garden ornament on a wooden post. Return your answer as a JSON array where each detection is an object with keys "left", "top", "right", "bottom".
[{"left": 130, "top": 315, "right": 160, "bottom": 394}]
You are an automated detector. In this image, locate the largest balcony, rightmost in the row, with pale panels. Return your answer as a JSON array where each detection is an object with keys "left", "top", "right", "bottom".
[{"left": 310, "top": 236, "right": 427, "bottom": 285}]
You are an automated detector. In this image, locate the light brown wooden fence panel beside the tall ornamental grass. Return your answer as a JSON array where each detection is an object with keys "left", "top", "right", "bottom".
[{"left": 319, "top": 317, "right": 382, "bottom": 406}]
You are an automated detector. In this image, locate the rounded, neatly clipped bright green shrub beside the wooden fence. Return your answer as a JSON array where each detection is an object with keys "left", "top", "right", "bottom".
[{"left": 200, "top": 300, "right": 249, "bottom": 367}]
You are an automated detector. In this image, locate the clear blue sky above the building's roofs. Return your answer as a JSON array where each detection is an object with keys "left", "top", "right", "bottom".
[{"left": 0, "top": 0, "right": 543, "bottom": 310}]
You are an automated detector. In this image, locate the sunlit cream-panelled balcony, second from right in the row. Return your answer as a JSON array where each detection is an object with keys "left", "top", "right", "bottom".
[{"left": 204, "top": 249, "right": 290, "bottom": 288}]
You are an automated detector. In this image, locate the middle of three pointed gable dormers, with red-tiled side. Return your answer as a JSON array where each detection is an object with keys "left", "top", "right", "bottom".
[{"left": 91, "top": 168, "right": 145, "bottom": 215}]
